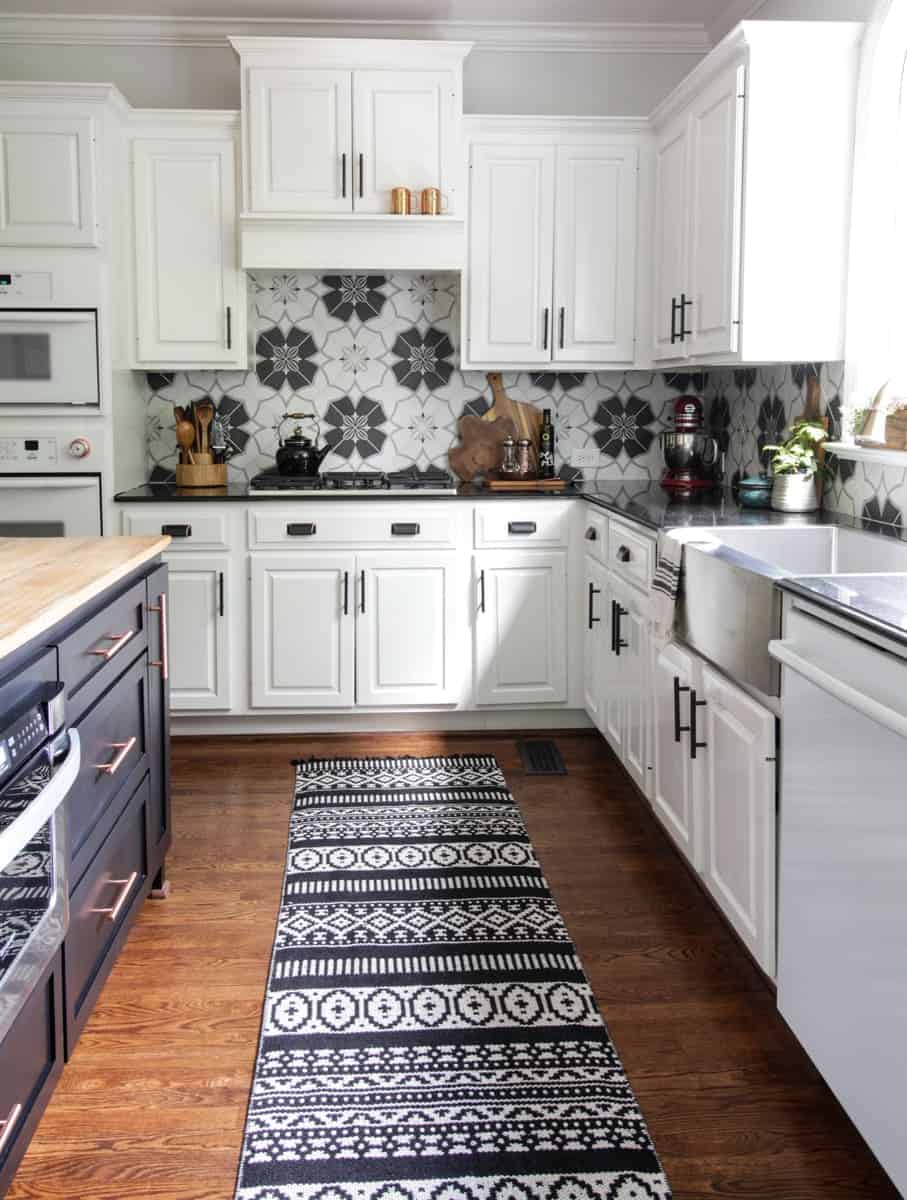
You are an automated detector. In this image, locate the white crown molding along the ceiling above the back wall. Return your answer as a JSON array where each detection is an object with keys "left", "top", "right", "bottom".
[{"left": 0, "top": 12, "right": 711, "bottom": 54}]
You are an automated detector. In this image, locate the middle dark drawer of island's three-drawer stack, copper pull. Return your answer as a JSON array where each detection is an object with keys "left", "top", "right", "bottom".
[{"left": 66, "top": 659, "right": 148, "bottom": 888}]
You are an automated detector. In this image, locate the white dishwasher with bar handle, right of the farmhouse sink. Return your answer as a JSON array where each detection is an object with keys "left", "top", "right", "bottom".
[{"left": 770, "top": 595, "right": 907, "bottom": 1193}]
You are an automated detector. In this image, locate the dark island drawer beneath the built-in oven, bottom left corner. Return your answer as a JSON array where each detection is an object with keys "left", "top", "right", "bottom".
[{"left": 0, "top": 953, "right": 64, "bottom": 1195}]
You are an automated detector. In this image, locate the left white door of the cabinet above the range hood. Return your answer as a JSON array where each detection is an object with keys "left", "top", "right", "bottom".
[{"left": 247, "top": 67, "right": 354, "bottom": 212}]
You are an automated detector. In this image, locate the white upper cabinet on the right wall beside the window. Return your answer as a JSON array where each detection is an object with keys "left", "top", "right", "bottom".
[{"left": 653, "top": 22, "right": 861, "bottom": 365}]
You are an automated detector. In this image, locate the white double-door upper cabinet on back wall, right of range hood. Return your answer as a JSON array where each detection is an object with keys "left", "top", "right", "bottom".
[{"left": 464, "top": 118, "right": 645, "bottom": 368}]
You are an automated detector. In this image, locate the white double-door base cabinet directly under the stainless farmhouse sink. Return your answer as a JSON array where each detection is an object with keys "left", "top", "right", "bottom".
[{"left": 654, "top": 643, "right": 776, "bottom": 976}]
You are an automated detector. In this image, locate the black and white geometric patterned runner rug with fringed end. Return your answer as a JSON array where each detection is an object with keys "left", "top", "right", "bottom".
[{"left": 236, "top": 757, "right": 671, "bottom": 1200}]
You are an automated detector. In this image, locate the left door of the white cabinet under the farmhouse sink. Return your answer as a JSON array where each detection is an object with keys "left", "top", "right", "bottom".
[{"left": 654, "top": 642, "right": 702, "bottom": 870}]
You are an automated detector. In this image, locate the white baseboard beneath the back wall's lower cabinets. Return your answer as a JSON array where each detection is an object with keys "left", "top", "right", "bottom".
[{"left": 170, "top": 708, "right": 593, "bottom": 738}]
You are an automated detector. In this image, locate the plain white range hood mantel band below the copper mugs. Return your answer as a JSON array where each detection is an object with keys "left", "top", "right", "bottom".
[{"left": 240, "top": 214, "right": 465, "bottom": 271}]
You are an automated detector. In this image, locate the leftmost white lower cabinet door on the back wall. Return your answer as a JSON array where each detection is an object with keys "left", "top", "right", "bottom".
[{"left": 167, "top": 553, "right": 235, "bottom": 712}]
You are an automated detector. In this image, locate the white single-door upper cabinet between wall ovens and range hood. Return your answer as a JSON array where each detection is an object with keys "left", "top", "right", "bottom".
[{"left": 132, "top": 139, "right": 247, "bottom": 366}]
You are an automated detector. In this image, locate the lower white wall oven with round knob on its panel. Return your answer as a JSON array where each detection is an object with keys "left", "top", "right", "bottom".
[{"left": 0, "top": 430, "right": 103, "bottom": 538}]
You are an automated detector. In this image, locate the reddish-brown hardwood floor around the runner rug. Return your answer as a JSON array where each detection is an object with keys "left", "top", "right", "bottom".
[{"left": 7, "top": 733, "right": 897, "bottom": 1200}]
